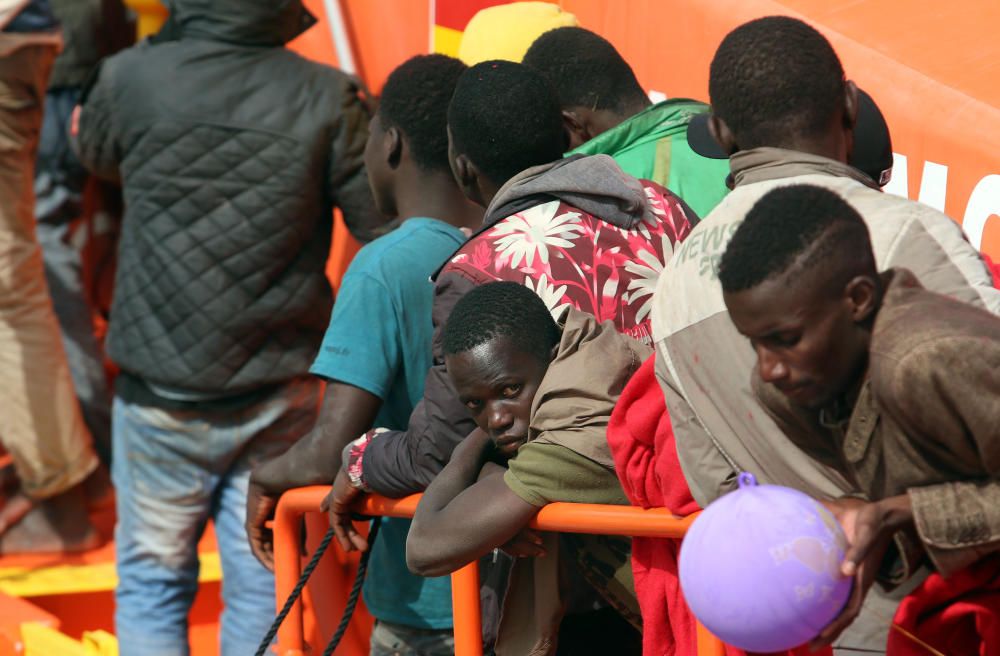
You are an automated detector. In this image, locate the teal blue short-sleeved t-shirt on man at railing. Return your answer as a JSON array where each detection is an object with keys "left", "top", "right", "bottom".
[{"left": 310, "top": 218, "right": 465, "bottom": 629}]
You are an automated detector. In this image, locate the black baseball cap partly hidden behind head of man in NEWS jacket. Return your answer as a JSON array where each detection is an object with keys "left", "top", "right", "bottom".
[{"left": 687, "top": 89, "right": 892, "bottom": 187}]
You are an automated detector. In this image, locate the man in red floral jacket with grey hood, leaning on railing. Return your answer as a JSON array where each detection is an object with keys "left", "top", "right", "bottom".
[{"left": 330, "top": 61, "right": 691, "bottom": 549}]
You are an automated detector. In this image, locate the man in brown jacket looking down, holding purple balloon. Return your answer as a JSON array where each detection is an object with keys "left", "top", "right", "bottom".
[{"left": 719, "top": 185, "right": 1000, "bottom": 653}]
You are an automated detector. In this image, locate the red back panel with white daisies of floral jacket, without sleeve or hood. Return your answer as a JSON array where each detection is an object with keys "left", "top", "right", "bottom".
[{"left": 441, "top": 180, "right": 691, "bottom": 344}]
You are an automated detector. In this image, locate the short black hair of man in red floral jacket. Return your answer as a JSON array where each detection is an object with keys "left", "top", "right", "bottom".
[{"left": 448, "top": 60, "right": 568, "bottom": 185}]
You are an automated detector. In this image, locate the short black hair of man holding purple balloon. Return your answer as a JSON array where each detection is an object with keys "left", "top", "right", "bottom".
[{"left": 719, "top": 185, "right": 877, "bottom": 294}]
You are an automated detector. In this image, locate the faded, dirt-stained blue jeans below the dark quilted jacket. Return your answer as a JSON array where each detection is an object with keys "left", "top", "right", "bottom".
[{"left": 112, "top": 379, "right": 321, "bottom": 656}]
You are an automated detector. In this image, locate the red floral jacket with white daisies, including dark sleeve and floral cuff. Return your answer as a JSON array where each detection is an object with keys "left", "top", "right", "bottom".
[{"left": 344, "top": 180, "right": 691, "bottom": 497}]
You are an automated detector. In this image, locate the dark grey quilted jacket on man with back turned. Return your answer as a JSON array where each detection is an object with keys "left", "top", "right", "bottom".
[{"left": 76, "top": 0, "right": 383, "bottom": 398}]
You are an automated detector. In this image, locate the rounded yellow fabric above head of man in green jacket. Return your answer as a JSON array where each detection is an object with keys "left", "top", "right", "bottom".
[{"left": 458, "top": 2, "right": 579, "bottom": 66}]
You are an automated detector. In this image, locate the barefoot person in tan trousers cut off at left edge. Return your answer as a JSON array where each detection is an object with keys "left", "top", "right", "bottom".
[{"left": 0, "top": 0, "right": 98, "bottom": 553}]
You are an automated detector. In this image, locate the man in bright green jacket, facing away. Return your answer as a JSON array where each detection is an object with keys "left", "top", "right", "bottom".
[{"left": 524, "top": 27, "right": 729, "bottom": 216}]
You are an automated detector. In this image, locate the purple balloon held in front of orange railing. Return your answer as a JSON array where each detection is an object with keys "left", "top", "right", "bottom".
[{"left": 680, "top": 473, "right": 851, "bottom": 652}]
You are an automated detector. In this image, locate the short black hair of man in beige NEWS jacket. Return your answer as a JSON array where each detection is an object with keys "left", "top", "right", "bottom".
[{"left": 708, "top": 16, "right": 844, "bottom": 150}]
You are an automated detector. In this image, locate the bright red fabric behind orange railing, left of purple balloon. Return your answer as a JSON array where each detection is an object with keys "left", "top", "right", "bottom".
[{"left": 608, "top": 356, "right": 830, "bottom": 656}]
